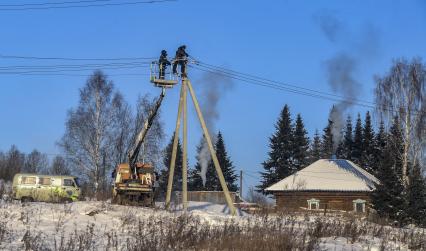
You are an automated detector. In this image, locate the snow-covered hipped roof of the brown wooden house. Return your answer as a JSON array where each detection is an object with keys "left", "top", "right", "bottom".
[{"left": 265, "top": 159, "right": 379, "bottom": 192}]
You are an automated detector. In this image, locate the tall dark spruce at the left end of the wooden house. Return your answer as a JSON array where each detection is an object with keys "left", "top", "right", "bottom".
[{"left": 257, "top": 105, "right": 293, "bottom": 193}]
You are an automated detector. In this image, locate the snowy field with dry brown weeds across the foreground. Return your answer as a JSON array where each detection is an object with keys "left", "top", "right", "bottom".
[{"left": 0, "top": 200, "right": 426, "bottom": 251}]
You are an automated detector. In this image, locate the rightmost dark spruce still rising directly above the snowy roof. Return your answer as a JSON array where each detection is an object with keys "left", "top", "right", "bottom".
[{"left": 361, "top": 111, "right": 377, "bottom": 174}]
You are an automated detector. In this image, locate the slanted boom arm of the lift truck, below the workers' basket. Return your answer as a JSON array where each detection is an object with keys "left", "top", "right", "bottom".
[{"left": 128, "top": 88, "right": 165, "bottom": 173}]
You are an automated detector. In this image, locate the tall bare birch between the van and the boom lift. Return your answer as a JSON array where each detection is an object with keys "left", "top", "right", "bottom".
[{"left": 59, "top": 71, "right": 114, "bottom": 194}]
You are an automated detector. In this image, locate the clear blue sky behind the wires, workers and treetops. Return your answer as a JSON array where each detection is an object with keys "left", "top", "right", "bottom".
[{"left": 0, "top": 0, "right": 426, "bottom": 194}]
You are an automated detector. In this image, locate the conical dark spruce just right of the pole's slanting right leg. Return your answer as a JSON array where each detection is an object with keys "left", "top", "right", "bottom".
[{"left": 215, "top": 131, "right": 238, "bottom": 192}]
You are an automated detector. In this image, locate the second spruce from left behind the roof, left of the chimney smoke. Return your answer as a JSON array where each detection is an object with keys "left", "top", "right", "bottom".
[{"left": 293, "top": 114, "right": 309, "bottom": 173}]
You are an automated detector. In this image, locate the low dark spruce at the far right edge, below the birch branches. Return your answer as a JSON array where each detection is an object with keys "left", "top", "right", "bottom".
[{"left": 407, "top": 162, "right": 426, "bottom": 227}]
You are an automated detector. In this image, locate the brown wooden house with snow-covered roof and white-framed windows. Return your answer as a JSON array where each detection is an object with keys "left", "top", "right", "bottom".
[{"left": 265, "top": 159, "right": 379, "bottom": 213}]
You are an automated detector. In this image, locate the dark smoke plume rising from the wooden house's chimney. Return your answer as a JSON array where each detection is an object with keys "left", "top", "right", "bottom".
[{"left": 314, "top": 12, "right": 379, "bottom": 151}]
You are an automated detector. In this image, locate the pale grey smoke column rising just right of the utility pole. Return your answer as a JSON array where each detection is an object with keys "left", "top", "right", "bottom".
[{"left": 197, "top": 72, "right": 233, "bottom": 186}]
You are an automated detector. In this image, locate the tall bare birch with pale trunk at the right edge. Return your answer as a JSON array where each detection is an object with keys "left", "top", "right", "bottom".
[{"left": 375, "top": 59, "right": 426, "bottom": 186}]
